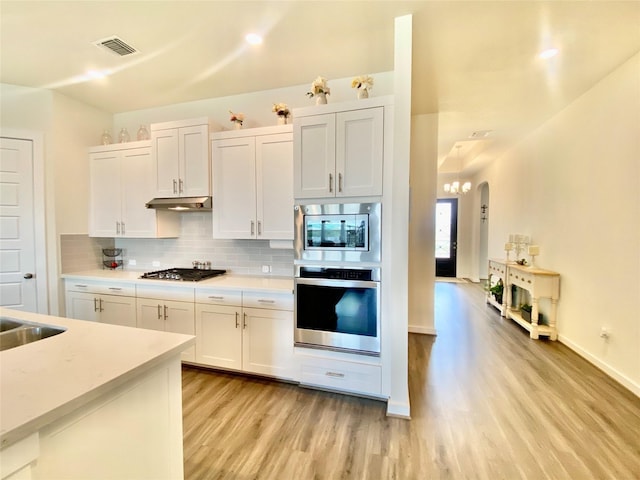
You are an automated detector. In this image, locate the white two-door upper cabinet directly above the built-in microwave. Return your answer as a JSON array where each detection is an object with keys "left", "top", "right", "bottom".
[{"left": 294, "top": 106, "right": 384, "bottom": 198}]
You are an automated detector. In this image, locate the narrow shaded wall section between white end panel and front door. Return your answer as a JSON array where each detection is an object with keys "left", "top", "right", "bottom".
[{"left": 409, "top": 114, "right": 438, "bottom": 334}]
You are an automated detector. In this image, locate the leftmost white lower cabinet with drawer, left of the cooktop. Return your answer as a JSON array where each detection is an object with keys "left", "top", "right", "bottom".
[{"left": 66, "top": 281, "right": 136, "bottom": 327}]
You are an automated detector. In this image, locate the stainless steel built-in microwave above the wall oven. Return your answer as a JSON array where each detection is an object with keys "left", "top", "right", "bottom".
[{"left": 294, "top": 203, "right": 381, "bottom": 263}]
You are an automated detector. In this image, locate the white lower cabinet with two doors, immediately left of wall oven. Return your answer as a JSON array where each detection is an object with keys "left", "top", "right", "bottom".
[{"left": 196, "top": 290, "right": 296, "bottom": 379}]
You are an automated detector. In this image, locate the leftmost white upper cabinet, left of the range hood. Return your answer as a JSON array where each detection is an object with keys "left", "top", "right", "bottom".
[{"left": 89, "top": 141, "right": 180, "bottom": 238}]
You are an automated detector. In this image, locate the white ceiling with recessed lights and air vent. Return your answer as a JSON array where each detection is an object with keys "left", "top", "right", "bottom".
[{"left": 0, "top": 0, "right": 640, "bottom": 172}]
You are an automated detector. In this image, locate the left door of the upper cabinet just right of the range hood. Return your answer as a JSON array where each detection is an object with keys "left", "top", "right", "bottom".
[{"left": 212, "top": 137, "right": 258, "bottom": 239}]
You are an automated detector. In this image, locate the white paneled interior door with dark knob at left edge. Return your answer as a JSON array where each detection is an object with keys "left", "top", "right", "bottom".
[{"left": 0, "top": 138, "right": 38, "bottom": 312}]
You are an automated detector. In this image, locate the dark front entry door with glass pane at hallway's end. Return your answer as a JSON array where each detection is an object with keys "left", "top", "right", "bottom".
[{"left": 436, "top": 198, "right": 458, "bottom": 277}]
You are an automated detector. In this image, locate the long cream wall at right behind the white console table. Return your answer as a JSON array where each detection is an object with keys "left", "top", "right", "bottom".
[{"left": 474, "top": 54, "right": 640, "bottom": 395}]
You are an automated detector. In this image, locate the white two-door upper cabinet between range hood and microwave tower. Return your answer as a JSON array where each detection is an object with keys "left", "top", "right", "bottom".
[{"left": 211, "top": 126, "right": 293, "bottom": 240}]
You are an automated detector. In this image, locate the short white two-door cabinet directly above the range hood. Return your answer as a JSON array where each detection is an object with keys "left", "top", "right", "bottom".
[{"left": 151, "top": 118, "right": 211, "bottom": 198}]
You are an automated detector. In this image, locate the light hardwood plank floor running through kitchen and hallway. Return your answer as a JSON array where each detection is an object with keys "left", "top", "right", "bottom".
[{"left": 183, "top": 282, "right": 640, "bottom": 480}]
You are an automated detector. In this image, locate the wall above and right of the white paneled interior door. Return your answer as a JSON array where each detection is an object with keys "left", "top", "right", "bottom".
[{"left": 0, "top": 84, "right": 111, "bottom": 315}]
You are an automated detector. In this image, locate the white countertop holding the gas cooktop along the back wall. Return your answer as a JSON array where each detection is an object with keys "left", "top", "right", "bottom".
[{"left": 62, "top": 270, "right": 293, "bottom": 293}]
